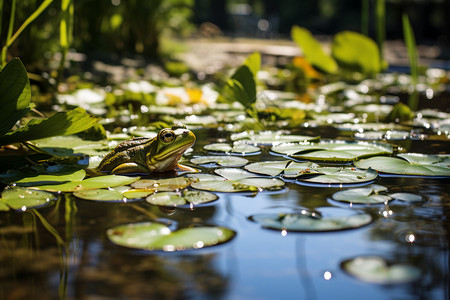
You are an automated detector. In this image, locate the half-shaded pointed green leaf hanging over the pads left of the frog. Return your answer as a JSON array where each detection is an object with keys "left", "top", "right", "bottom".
[{"left": 0, "top": 108, "right": 97, "bottom": 145}]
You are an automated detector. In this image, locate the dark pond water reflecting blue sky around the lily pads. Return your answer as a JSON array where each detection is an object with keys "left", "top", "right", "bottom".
[{"left": 0, "top": 128, "right": 450, "bottom": 299}]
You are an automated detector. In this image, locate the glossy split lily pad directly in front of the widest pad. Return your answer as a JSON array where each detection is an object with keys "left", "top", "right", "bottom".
[{"left": 297, "top": 167, "right": 378, "bottom": 186}]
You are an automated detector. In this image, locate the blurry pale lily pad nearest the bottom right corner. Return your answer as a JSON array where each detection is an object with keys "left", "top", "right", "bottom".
[{"left": 341, "top": 256, "right": 422, "bottom": 284}]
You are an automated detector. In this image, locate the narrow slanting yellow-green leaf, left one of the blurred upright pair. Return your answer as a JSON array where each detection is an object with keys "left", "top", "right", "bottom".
[{"left": 291, "top": 26, "right": 338, "bottom": 74}]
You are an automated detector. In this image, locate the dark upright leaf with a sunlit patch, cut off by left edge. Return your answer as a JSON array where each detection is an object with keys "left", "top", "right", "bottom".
[{"left": 0, "top": 58, "right": 31, "bottom": 135}]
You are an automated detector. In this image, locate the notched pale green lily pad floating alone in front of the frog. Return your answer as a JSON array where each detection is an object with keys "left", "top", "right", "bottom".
[{"left": 106, "top": 222, "right": 236, "bottom": 251}]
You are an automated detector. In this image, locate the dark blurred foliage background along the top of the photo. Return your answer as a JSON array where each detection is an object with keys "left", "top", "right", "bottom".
[{"left": 0, "top": 0, "right": 450, "bottom": 69}]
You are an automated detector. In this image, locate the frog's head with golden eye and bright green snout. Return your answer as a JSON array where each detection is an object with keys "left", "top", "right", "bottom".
[{"left": 146, "top": 123, "right": 195, "bottom": 172}]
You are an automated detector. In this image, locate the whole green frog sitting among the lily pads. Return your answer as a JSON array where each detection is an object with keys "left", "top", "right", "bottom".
[{"left": 96, "top": 123, "right": 195, "bottom": 174}]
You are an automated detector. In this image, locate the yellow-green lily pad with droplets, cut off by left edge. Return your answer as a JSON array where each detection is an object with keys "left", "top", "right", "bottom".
[{"left": 1, "top": 187, "right": 56, "bottom": 211}]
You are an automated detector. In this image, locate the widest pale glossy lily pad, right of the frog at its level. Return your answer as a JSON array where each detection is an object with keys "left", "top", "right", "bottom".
[{"left": 272, "top": 142, "right": 392, "bottom": 162}]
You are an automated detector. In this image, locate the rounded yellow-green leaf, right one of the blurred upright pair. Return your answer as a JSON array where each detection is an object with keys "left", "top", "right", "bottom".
[{"left": 331, "top": 31, "right": 382, "bottom": 75}]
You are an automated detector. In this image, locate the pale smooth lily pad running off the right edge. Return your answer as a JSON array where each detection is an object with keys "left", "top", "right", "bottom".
[{"left": 354, "top": 156, "right": 450, "bottom": 177}]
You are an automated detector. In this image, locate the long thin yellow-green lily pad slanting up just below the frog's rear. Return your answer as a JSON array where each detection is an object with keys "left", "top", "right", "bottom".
[{"left": 36, "top": 175, "right": 139, "bottom": 192}]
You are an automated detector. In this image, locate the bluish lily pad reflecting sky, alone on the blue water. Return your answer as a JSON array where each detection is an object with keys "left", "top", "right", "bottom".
[{"left": 250, "top": 208, "right": 372, "bottom": 232}]
